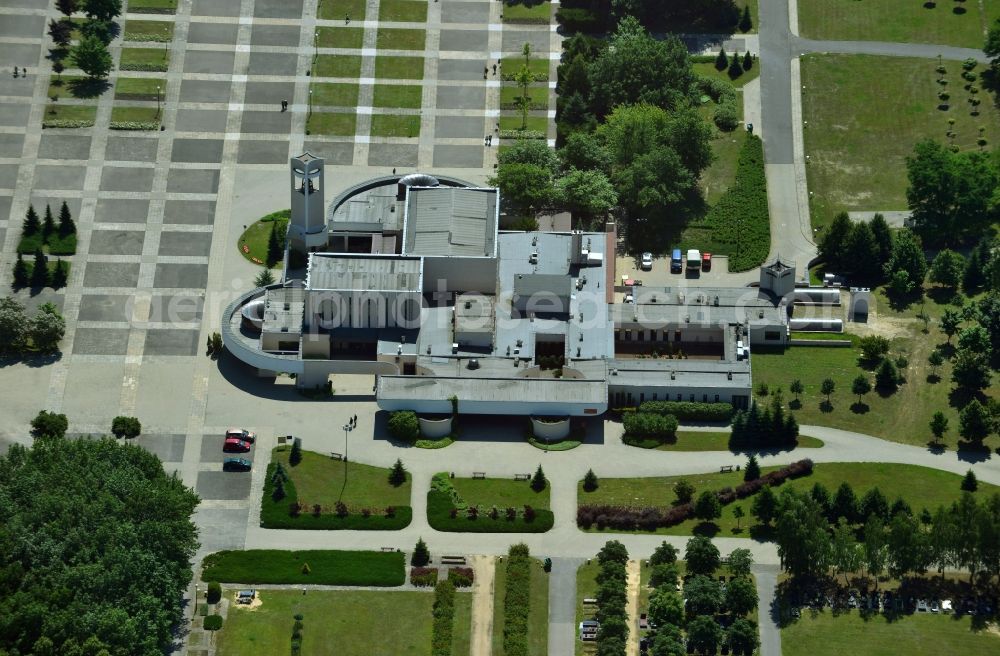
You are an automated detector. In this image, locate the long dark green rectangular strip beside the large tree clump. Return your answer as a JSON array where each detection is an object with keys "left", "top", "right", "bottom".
[{"left": 201, "top": 549, "right": 406, "bottom": 587}]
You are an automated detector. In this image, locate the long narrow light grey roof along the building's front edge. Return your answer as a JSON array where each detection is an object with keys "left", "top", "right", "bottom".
[{"left": 377, "top": 376, "right": 608, "bottom": 404}]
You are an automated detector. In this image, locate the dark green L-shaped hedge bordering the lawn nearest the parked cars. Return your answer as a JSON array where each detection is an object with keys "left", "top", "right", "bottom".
[{"left": 260, "top": 462, "right": 413, "bottom": 531}]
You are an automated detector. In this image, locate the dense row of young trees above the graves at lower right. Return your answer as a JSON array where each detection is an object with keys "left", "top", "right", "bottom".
[{"left": 753, "top": 486, "right": 1000, "bottom": 583}]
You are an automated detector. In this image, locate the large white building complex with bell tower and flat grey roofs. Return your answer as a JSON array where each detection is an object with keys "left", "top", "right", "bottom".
[{"left": 222, "top": 154, "right": 808, "bottom": 426}]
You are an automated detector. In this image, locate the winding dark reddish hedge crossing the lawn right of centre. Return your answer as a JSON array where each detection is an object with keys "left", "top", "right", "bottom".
[{"left": 576, "top": 458, "right": 813, "bottom": 531}]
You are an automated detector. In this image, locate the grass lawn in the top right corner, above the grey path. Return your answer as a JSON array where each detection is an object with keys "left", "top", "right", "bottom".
[{"left": 799, "top": 0, "right": 1000, "bottom": 49}]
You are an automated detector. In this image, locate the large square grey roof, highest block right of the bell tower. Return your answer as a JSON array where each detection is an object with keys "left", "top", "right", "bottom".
[{"left": 403, "top": 187, "right": 497, "bottom": 257}]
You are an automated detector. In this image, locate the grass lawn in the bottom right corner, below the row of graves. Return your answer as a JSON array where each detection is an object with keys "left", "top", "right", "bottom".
[{"left": 781, "top": 609, "right": 1000, "bottom": 656}]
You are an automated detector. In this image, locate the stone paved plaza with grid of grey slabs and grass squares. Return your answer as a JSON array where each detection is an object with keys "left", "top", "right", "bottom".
[{"left": 0, "top": 0, "right": 561, "bottom": 532}]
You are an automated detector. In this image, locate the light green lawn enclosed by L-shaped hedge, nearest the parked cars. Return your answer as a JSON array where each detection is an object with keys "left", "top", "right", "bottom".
[{"left": 271, "top": 447, "right": 411, "bottom": 508}]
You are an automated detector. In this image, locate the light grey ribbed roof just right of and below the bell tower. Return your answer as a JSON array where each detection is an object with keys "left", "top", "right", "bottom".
[{"left": 306, "top": 253, "right": 422, "bottom": 292}]
